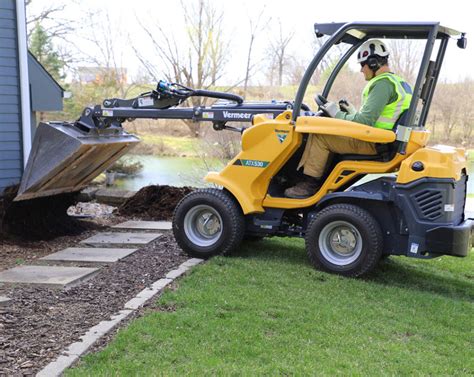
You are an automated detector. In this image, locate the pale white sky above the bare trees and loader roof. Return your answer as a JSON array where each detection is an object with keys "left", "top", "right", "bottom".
[{"left": 27, "top": 0, "right": 474, "bottom": 85}]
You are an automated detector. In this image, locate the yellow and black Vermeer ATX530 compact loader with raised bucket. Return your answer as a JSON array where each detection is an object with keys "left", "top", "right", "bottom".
[{"left": 18, "top": 22, "right": 473, "bottom": 277}]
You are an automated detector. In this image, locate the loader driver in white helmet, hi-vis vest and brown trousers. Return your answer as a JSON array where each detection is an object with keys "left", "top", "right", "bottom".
[{"left": 285, "top": 39, "right": 413, "bottom": 198}]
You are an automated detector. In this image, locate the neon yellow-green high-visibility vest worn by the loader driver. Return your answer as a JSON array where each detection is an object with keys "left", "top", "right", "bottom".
[{"left": 362, "top": 72, "right": 413, "bottom": 130}]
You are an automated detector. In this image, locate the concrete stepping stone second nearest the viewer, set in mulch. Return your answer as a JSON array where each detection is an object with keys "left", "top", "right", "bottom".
[{"left": 40, "top": 247, "right": 138, "bottom": 263}]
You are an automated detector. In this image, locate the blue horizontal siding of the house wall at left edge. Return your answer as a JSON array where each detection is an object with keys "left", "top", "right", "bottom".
[{"left": 0, "top": 0, "right": 23, "bottom": 193}]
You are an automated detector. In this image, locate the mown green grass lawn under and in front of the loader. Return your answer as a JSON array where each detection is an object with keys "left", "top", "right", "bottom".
[{"left": 67, "top": 239, "right": 474, "bottom": 376}]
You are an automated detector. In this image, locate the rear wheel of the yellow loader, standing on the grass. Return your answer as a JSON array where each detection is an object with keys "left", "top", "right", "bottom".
[{"left": 305, "top": 204, "right": 383, "bottom": 277}]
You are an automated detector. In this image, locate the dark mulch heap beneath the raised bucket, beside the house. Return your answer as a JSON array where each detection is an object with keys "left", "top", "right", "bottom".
[{"left": 0, "top": 186, "right": 94, "bottom": 240}]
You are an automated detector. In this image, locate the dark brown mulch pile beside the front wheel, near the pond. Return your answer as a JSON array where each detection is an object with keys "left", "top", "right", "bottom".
[{"left": 118, "top": 185, "right": 195, "bottom": 220}]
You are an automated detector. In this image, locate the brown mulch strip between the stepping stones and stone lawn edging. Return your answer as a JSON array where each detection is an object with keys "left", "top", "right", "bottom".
[{"left": 0, "top": 235, "right": 188, "bottom": 375}]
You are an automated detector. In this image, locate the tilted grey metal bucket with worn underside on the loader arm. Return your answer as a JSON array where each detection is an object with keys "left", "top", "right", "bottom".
[{"left": 15, "top": 122, "right": 140, "bottom": 201}]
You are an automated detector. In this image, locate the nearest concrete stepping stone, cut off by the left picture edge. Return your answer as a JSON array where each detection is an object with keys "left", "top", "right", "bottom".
[{"left": 0, "top": 266, "right": 99, "bottom": 288}]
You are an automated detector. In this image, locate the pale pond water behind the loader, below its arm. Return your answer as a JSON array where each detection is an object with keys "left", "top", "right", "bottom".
[{"left": 114, "top": 156, "right": 474, "bottom": 194}]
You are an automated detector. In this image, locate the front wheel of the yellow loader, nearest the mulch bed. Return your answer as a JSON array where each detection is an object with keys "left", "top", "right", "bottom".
[{"left": 173, "top": 189, "right": 245, "bottom": 258}]
